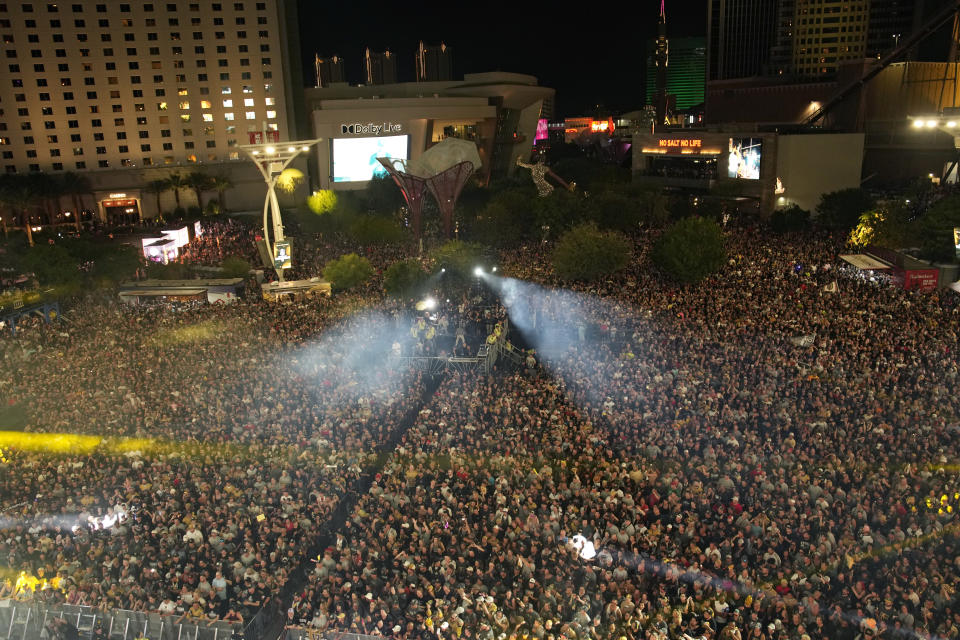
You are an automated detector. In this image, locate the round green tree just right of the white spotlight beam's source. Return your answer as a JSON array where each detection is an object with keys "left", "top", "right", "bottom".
[{"left": 552, "top": 222, "right": 631, "bottom": 281}]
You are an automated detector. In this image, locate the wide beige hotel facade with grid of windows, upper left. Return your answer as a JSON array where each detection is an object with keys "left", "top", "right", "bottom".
[{"left": 0, "top": 0, "right": 303, "bottom": 173}]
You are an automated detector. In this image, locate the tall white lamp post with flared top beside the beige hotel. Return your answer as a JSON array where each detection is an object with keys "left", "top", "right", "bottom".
[{"left": 238, "top": 139, "right": 320, "bottom": 282}]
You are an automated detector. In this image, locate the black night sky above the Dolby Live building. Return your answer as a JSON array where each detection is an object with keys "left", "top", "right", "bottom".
[{"left": 299, "top": 0, "right": 707, "bottom": 117}]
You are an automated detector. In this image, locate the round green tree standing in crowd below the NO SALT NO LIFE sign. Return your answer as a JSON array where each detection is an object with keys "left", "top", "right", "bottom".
[{"left": 652, "top": 217, "right": 726, "bottom": 283}]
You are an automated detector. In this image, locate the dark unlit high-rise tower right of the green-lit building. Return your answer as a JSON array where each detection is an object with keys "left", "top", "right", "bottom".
[{"left": 707, "top": 0, "right": 780, "bottom": 81}]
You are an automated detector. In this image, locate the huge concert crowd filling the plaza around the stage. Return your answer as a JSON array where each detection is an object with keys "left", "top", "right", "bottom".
[{"left": 0, "top": 221, "right": 960, "bottom": 640}]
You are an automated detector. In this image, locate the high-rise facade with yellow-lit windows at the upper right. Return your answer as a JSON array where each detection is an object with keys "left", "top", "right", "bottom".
[{"left": 793, "top": 0, "right": 870, "bottom": 78}]
